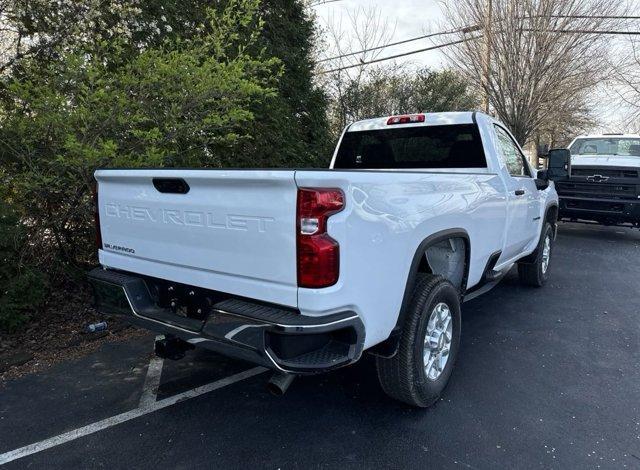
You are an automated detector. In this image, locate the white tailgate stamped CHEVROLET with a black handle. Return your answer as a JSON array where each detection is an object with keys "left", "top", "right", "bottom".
[{"left": 96, "top": 170, "right": 297, "bottom": 306}]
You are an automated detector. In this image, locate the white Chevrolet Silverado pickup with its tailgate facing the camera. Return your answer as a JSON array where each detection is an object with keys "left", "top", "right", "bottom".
[{"left": 89, "top": 112, "right": 558, "bottom": 407}]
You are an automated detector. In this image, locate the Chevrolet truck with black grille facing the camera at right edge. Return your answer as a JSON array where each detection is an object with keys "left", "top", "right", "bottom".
[{"left": 555, "top": 134, "right": 640, "bottom": 227}]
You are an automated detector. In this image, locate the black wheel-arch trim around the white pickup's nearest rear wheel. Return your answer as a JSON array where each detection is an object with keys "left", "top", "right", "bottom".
[{"left": 368, "top": 228, "right": 471, "bottom": 358}]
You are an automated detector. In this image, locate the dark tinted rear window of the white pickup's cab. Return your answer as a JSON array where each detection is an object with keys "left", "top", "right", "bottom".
[{"left": 333, "top": 124, "right": 487, "bottom": 169}]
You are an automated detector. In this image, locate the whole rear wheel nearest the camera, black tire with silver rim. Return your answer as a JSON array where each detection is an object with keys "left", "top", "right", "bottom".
[{"left": 376, "top": 274, "right": 461, "bottom": 408}]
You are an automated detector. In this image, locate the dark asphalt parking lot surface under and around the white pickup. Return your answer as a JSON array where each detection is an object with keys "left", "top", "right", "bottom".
[{"left": 0, "top": 224, "right": 640, "bottom": 469}]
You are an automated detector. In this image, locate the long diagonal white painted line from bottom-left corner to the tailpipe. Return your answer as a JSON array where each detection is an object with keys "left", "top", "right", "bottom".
[{"left": 0, "top": 367, "right": 267, "bottom": 465}]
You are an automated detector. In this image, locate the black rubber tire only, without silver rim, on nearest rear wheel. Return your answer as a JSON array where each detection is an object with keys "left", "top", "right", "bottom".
[{"left": 376, "top": 274, "right": 461, "bottom": 408}]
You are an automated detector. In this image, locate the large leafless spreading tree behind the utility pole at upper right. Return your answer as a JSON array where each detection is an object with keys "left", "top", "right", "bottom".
[{"left": 446, "top": 0, "right": 622, "bottom": 144}]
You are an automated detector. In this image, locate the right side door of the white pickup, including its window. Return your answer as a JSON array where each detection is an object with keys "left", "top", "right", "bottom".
[{"left": 494, "top": 124, "right": 540, "bottom": 261}]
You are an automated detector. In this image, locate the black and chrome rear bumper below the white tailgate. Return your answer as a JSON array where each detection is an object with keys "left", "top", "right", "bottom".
[{"left": 89, "top": 268, "right": 364, "bottom": 374}]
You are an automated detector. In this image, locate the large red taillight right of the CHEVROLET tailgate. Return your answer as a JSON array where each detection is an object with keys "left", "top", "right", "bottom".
[{"left": 296, "top": 188, "right": 344, "bottom": 288}]
